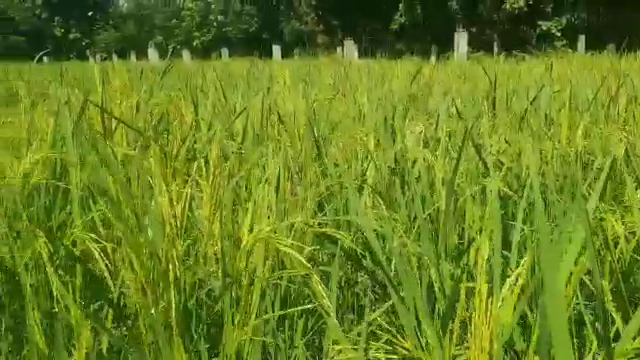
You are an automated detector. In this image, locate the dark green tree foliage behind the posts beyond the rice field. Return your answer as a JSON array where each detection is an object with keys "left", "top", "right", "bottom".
[{"left": 0, "top": 0, "right": 640, "bottom": 58}]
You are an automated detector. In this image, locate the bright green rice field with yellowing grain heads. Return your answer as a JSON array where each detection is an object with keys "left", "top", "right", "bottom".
[{"left": 0, "top": 55, "right": 640, "bottom": 360}]
